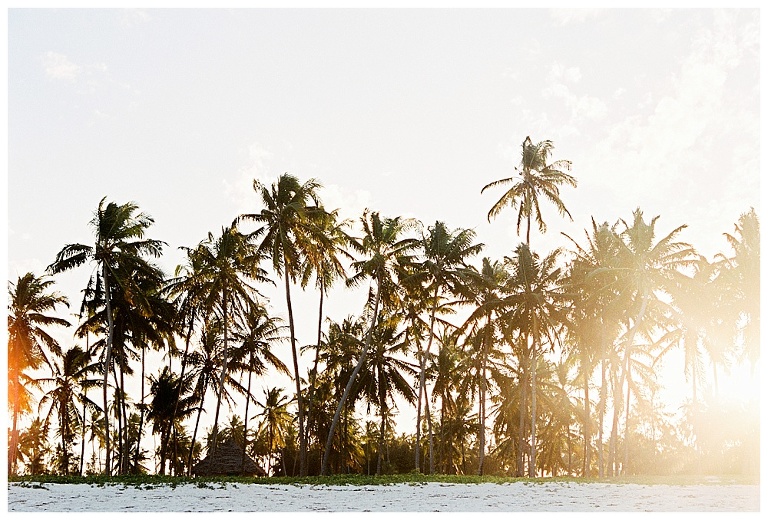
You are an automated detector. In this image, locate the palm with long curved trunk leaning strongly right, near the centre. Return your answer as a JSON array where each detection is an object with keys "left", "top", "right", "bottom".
[{"left": 320, "top": 210, "right": 418, "bottom": 475}]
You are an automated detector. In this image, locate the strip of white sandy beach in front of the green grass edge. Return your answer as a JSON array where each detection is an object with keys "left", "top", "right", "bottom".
[{"left": 8, "top": 482, "right": 760, "bottom": 513}]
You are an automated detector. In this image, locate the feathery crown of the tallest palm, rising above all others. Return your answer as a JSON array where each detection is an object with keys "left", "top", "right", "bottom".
[{"left": 480, "top": 137, "right": 576, "bottom": 245}]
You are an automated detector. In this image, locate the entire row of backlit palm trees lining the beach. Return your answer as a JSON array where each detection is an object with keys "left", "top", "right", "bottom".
[{"left": 8, "top": 137, "right": 759, "bottom": 477}]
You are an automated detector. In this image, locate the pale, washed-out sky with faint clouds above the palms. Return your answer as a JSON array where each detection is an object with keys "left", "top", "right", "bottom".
[{"left": 7, "top": 8, "right": 761, "bottom": 446}]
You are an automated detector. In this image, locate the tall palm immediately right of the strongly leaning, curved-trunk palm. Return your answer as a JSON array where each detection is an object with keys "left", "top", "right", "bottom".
[{"left": 405, "top": 221, "right": 483, "bottom": 473}]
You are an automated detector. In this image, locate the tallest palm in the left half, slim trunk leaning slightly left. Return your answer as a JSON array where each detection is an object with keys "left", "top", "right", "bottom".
[{"left": 237, "top": 173, "right": 326, "bottom": 476}]
